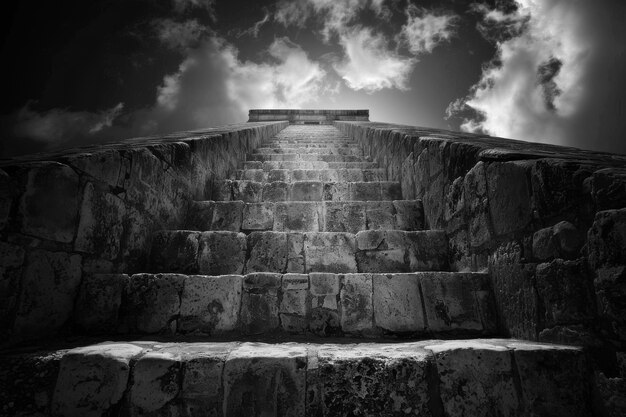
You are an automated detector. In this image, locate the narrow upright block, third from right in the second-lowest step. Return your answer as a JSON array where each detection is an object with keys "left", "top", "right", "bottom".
[{"left": 341, "top": 274, "right": 374, "bottom": 333}]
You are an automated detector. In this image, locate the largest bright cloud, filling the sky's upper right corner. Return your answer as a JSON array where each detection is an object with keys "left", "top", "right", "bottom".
[{"left": 449, "top": 0, "right": 626, "bottom": 152}]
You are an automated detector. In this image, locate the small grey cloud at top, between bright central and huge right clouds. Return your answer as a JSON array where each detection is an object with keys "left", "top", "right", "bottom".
[{"left": 400, "top": 4, "right": 458, "bottom": 55}]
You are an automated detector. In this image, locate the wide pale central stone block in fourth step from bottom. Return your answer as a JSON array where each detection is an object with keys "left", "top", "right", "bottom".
[{"left": 274, "top": 201, "right": 321, "bottom": 232}]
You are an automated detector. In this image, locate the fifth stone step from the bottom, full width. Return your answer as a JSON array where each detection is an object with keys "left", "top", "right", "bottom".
[{"left": 210, "top": 180, "right": 402, "bottom": 203}]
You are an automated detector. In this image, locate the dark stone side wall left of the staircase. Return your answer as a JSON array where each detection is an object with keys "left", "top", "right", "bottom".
[{"left": 0, "top": 122, "right": 288, "bottom": 341}]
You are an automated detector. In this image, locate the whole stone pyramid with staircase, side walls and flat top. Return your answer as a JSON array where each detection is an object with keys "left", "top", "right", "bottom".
[{"left": 0, "top": 109, "right": 626, "bottom": 416}]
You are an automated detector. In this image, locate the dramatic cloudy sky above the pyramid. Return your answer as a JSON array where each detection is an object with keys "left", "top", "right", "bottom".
[{"left": 0, "top": 0, "right": 626, "bottom": 157}]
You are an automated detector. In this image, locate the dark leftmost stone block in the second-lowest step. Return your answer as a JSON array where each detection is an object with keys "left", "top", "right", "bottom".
[{"left": 74, "top": 274, "right": 129, "bottom": 333}]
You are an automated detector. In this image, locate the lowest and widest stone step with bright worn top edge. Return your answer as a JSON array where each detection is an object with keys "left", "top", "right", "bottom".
[{"left": 13, "top": 339, "right": 593, "bottom": 417}]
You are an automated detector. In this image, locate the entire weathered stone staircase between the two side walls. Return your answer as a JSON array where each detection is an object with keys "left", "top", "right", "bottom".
[{"left": 20, "top": 125, "right": 591, "bottom": 416}]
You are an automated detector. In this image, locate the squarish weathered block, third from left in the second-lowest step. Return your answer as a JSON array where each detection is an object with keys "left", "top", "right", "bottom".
[{"left": 178, "top": 275, "right": 243, "bottom": 334}]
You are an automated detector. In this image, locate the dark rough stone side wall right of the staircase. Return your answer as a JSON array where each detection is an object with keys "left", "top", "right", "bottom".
[{"left": 335, "top": 121, "right": 626, "bottom": 369}]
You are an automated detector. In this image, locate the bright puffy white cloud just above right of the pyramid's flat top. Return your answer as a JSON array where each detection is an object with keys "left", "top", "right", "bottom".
[{"left": 334, "top": 28, "right": 417, "bottom": 93}]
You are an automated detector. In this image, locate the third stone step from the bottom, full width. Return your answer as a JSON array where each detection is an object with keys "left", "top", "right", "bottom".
[{"left": 150, "top": 230, "right": 448, "bottom": 275}]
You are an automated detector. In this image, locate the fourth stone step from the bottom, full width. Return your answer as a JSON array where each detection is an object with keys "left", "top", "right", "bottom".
[{"left": 185, "top": 200, "right": 424, "bottom": 233}]
